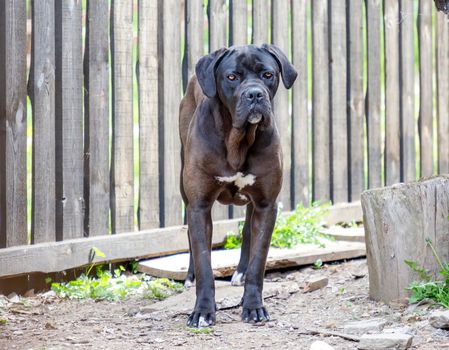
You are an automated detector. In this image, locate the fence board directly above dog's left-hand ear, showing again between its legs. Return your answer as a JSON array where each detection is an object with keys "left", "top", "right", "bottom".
[{"left": 207, "top": 0, "right": 229, "bottom": 220}]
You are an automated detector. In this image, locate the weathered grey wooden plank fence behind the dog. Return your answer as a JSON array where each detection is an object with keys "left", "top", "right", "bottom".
[{"left": 0, "top": 0, "right": 449, "bottom": 276}]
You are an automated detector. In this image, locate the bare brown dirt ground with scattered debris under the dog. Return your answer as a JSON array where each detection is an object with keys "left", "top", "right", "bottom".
[{"left": 0, "top": 259, "right": 449, "bottom": 350}]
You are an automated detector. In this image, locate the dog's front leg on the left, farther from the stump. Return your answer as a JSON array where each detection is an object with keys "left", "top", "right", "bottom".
[{"left": 187, "top": 203, "right": 216, "bottom": 327}]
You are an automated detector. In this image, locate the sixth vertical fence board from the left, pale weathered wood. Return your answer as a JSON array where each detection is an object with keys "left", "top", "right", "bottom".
[{"left": 138, "top": 0, "right": 159, "bottom": 230}]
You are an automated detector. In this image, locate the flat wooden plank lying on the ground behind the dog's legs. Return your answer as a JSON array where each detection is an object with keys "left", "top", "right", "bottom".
[{"left": 137, "top": 241, "right": 365, "bottom": 280}]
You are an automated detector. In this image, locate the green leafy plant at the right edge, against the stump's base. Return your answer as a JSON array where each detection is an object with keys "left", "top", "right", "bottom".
[{"left": 405, "top": 239, "right": 449, "bottom": 309}]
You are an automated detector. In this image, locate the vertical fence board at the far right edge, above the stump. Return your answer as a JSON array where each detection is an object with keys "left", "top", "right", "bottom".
[{"left": 436, "top": 12, "right": 449, "bottom": 174}]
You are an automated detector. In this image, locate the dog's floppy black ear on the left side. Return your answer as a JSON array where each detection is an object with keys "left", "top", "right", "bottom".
[{"left": 195, "top": 47, "right": 228, "bottom": 97}]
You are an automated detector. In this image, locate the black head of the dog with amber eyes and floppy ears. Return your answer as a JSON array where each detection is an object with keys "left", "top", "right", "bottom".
[{"left": 195, "top": 45, "right": 297, "bottom": 129}]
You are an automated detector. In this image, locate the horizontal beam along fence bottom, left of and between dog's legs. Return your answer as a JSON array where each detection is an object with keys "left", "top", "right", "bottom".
[{"left": 0, "top": 220, "right": 239, "bottom": 277}]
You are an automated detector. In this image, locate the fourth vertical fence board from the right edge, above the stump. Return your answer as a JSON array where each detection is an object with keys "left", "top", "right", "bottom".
[{"left": 384, "top": 0, "right": 401, "bottom": 185}]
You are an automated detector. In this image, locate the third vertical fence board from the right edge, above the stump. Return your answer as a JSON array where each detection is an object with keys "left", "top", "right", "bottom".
[{"left": 400, "top": 0, "right": 416, "bottom": 181}]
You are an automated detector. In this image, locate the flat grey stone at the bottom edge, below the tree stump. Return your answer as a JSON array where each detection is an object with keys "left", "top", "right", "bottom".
[{"left": 358, "top": 333, "right": 413, "bottom": 350}]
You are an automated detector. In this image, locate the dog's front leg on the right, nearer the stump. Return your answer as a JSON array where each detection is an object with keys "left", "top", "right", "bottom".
[{"left": 242, "top": 202, "right": 277, "bottom": 322}]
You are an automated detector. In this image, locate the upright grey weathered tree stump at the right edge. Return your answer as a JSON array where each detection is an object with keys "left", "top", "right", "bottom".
[{"left": 362, "top": 176, "right": 449, "bottom": 302}]
